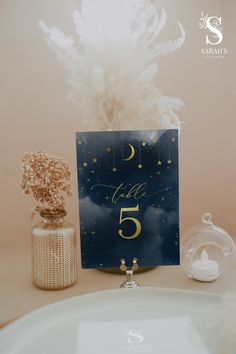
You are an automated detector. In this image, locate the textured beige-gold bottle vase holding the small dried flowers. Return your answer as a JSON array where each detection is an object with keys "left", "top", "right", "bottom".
[{"left": 32, "top": 212, "right": 77, "bottom": 290}]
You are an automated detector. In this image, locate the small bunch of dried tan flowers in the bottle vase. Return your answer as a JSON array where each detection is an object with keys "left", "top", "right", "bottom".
[{"left": 21, "top": 151, "right": 72, "bottom": 214}]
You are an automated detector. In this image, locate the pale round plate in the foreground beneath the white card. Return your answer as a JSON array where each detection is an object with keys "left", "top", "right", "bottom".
[{"left": 0, "top": 288, "right": 220, "bottom": 354}]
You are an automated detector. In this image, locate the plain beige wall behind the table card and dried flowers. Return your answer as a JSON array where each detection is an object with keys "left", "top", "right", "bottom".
[{"left": 0, "top": 0, "right": 236, "bottom": 248}]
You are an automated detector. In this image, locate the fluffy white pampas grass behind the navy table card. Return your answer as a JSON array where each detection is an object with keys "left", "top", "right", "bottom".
[{"left": 39, "top": 0, "right": 185, "bottom": 130}]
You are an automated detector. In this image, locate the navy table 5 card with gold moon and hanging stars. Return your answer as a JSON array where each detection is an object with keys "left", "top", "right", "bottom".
[{"left": 76, "top": 129, "right": 179, "bottom": 268}]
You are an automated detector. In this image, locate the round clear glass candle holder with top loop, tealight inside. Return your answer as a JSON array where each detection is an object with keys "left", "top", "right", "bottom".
[{"left": 181, "top": 213, "right": 235, "bottom": 282}]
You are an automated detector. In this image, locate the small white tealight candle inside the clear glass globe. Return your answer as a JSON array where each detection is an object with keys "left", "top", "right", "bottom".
[{"left": 192, "top": 249, "right": 220, "bottom": 281}]
